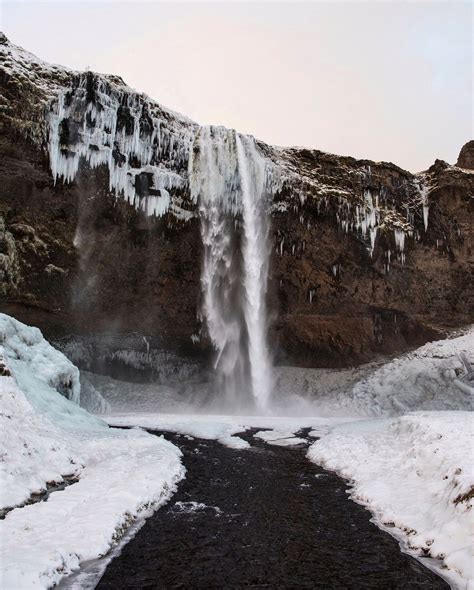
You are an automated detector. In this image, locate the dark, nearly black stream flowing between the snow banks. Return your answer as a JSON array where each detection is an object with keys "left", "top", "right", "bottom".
[{"left": 97, "top": 433, "right": 449, "bottom": 590}]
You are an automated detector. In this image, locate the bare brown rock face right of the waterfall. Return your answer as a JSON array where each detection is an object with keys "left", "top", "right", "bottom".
[{"left": 274, "top": 148, "right": 474, "bottom": 365}]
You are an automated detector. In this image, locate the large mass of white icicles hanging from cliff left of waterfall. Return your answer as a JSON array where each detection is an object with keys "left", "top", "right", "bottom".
[{"left": 48, "top": 74, "right": 195, "bottom": 221}]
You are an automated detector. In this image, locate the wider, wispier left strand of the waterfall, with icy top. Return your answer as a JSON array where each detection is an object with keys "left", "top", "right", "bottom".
[{"left": 190, "top": 127, "right": 245, "bottom": 402}]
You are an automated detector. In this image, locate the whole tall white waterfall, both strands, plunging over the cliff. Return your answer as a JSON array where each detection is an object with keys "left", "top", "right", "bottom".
[{"left": 189, "top": 127, "right": 272, "bottom": 409}]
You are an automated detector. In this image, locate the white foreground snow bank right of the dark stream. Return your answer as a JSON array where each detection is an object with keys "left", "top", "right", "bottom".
[{"left": 308, "top": 412, "right": 474, "bottom": 590}]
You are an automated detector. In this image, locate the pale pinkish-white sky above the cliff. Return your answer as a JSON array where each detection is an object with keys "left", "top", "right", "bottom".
[{"left": 0, "top": 0, "right": 473, "bottom": 171}]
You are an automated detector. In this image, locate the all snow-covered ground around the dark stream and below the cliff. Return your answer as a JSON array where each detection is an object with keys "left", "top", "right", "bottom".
[{"left": 0, "top": 314, "right": 474, "bottom": 590}]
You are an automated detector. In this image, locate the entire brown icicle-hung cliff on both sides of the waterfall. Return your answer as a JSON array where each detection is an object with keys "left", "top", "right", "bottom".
[{"left": 0, "top": 37, "right": 474, "bottom": 366}]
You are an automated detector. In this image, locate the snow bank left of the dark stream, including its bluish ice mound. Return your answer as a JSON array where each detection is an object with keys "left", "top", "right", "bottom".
[{"left": 0, "top": 314, "right": 184, "bottom": 590}]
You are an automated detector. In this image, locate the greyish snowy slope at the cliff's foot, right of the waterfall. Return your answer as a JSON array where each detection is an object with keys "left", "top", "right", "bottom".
[{"left": 276, "top": 328, "right": 474, "bottom": 418}]
